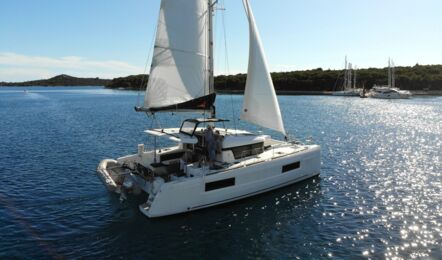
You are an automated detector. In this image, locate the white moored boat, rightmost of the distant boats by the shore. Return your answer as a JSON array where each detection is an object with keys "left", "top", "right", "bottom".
[{"left": 367, "top": 59, "right": 412, "bottom": 99}]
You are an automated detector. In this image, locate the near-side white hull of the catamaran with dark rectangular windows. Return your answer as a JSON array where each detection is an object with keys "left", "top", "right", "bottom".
[{"left": 139, "top": 145, "right": 321, "bottom": 218}]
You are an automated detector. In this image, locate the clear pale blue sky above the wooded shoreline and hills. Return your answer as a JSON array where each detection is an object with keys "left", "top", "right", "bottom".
[{"left": 0, "top": 0, "right": 442, "bottom": 82}]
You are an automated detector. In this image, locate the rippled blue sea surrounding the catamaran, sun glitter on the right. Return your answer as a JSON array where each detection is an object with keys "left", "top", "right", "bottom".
[{"left": 0, "top": 88, "right": 442, "bottom": 259}]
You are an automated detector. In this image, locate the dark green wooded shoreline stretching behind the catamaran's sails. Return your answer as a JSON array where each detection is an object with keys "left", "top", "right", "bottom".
[{"left": 106, "top": 64, "right": 442, "bottom": 93}]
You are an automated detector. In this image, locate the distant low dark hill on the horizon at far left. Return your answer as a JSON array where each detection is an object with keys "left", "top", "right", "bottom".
[{"left": 0, "top": 74, "right": 110, "bottom": 87}]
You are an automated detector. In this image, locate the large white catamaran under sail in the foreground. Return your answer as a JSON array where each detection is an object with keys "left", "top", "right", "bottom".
[{"left": 97, "top": 0, "right": 320, "bottom": 217}]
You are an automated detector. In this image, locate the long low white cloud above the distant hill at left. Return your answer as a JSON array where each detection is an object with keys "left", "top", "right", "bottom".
[{"left": 0, "top": 52, "right": 144, "bottom": 82}]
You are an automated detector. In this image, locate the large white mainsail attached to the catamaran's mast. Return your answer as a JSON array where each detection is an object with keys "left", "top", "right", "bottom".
[{"left": 144, "top": 0, "right": 210, "bottom": 108}]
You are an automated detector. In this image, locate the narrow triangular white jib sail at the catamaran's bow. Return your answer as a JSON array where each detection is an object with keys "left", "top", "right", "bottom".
[{"left": 241, "top": 0, "right": 286, "bottom": 135}]
